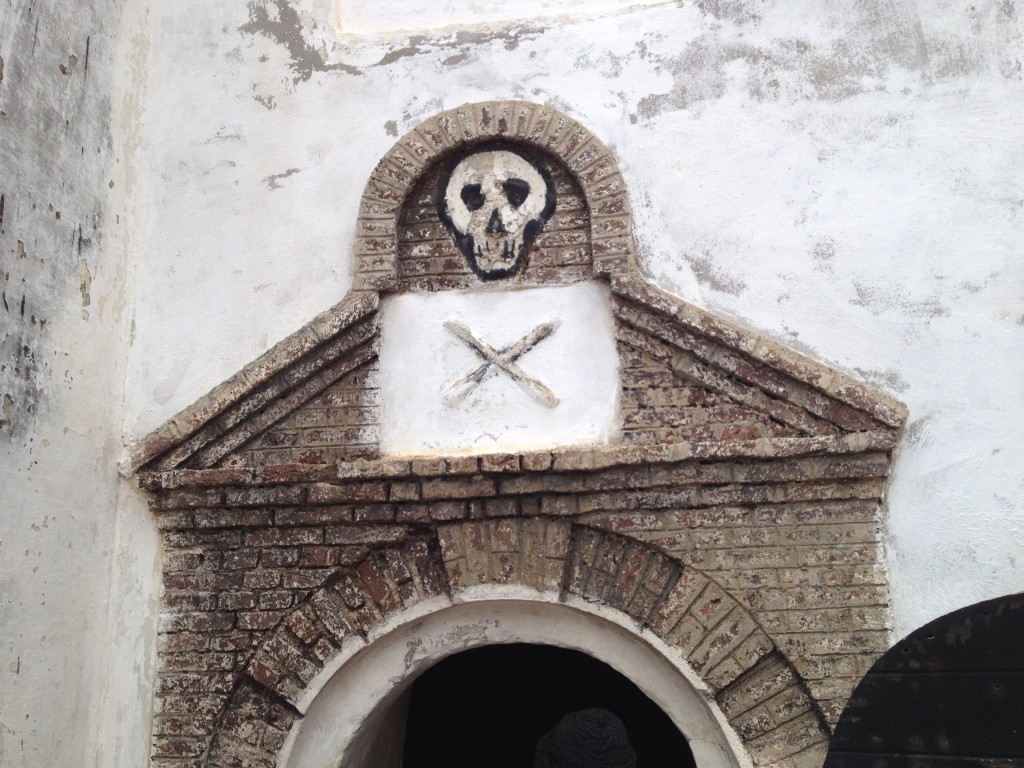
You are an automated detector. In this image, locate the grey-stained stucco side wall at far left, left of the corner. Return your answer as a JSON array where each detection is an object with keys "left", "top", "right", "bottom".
[{"left": 0, "top": 0, "right": 156, "bottom": 768}]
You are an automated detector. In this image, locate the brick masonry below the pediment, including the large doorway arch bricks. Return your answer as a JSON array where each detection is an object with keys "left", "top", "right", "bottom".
[{"left": 143, "top": 437, "right": 891, "bottom": 766}]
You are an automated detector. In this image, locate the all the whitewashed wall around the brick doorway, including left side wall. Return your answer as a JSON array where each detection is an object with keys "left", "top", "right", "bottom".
[{"left": 0, "top": 0, "right": 1024, "bottom": 766}]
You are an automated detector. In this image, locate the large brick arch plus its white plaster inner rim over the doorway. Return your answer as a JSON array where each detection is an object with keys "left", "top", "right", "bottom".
[{"left": 199, "top": 528, "right": 828, "bottom": 768}]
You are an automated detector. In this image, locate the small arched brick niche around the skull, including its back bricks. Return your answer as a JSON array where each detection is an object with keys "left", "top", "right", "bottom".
[{"left": 352, "top": 101, "right": 636, "bottom": 293}]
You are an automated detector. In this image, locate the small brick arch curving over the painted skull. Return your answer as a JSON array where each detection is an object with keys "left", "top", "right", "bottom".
[{"left": 353, "top": 101, "right": 636, "bottom": 293}]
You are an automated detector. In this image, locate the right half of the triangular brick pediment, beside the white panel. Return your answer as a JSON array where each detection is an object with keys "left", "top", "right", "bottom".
[{"left": 611, "top": 278, "right": 903, "bottom": 442}]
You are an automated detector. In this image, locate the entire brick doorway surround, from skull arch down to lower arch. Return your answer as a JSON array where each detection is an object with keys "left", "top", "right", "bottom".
[{"left": 128, "top": 102, "right": 906, "bottom": 768}]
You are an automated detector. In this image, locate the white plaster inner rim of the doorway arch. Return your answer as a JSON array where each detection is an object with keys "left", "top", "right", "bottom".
[{"left": 278, "top": 585, "right": 753, "bottom": 768}]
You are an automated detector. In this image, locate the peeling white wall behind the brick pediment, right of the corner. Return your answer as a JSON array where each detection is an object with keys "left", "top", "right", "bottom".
[{"left": 116, "top": 0, "right": 1024, "bottom": 651}]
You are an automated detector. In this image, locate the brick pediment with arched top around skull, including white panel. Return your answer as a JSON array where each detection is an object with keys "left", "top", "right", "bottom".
[{"left": 129, "top": 102, "right": 905, "bottom": 479}]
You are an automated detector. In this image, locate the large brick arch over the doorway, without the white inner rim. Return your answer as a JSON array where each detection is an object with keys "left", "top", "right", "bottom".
[{"left": 204, "top": 518, "right": 828, "bottom": 768}]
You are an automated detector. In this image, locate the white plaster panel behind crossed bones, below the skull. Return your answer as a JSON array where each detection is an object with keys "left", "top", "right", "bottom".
[{"left": 380, "top": 283, "right": 618, "bottom": 455}]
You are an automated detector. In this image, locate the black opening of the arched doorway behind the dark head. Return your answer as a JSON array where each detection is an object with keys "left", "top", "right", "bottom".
[{"left": 403, "top": 643, "right": 696, "bottom": 768}]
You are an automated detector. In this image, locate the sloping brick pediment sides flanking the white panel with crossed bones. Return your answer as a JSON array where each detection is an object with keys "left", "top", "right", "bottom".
[{"left": 133, "top": 276, "right": 903, "bottom": 471}]
